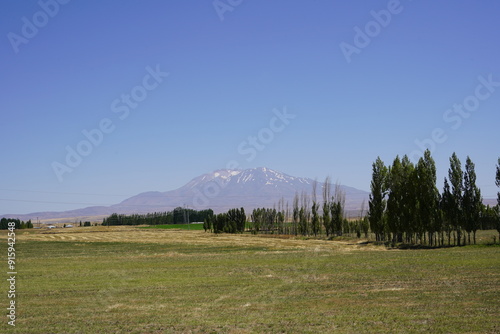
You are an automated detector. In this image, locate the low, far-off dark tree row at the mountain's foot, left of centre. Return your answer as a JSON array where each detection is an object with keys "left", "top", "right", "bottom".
[{"left": 102, "top": 207, "right": 213, "bottom": 226}]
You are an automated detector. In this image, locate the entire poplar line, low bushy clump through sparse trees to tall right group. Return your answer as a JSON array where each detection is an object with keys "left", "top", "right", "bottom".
[{"left": 204, "top": 150, "right": 500, "bottom": 246}]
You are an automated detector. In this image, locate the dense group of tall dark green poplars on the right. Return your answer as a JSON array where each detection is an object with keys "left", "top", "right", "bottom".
[{"left": 368, "top": 150, "right": 500, "bottom": 246}]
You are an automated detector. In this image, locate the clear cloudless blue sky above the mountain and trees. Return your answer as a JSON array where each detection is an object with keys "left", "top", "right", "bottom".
[{"left": 0, "top": 0, "right": 500, "bottom": 214}]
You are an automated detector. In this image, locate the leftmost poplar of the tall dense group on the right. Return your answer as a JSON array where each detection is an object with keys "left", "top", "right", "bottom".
[{"left": 368, "top": 157, "right": 388, "bottom": 241}]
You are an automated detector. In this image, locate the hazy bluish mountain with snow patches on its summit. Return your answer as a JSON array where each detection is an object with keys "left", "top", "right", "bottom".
[{"left": 5, "top": 168, "right": 368, "bottom": 222}]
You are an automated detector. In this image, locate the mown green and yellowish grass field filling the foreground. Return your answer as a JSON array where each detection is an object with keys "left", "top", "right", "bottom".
[{"left": 0, "top": 227, "right": 500, "bottom": 333}]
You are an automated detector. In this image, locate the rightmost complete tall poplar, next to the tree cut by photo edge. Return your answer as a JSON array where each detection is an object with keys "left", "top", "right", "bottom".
[{"left": 462, "top": 157, "right": 483, "bottom": 244}]
